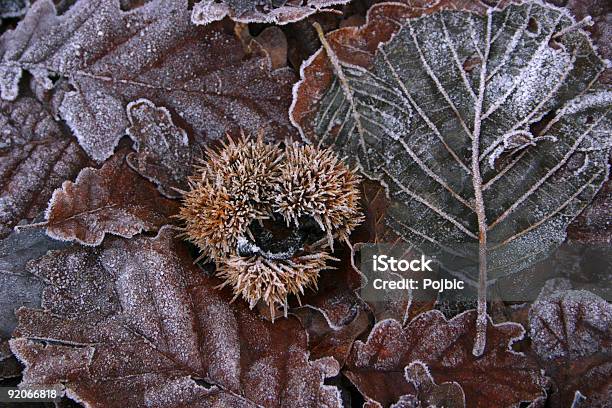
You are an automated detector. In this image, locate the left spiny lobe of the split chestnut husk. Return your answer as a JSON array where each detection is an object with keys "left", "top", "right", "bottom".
[{"left": 178, "top": 135, "right": 283, "bottom": 259}]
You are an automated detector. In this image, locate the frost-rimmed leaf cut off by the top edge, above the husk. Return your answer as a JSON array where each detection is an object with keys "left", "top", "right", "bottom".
[{"left": 191, "top": 0, "right": 351, "bottom": 25}]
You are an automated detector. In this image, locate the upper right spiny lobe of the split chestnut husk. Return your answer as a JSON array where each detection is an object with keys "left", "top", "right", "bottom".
[{"left": 273, "top": 143, "right": 364, "bottom": 248}]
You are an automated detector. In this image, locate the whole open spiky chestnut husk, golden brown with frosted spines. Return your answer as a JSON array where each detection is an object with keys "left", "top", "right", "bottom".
[{"left": 179, "top": 136, "right": 363, "bottom": 316}]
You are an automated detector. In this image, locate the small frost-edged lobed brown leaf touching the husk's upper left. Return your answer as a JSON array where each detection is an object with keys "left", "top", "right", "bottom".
[{"left": 127, "top": 99, "right": 202, "bottom": 198}]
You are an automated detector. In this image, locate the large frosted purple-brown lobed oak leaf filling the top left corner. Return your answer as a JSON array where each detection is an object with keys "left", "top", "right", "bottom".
[{"left": 0, "top": 0, "right": 293, "bottom": 161}]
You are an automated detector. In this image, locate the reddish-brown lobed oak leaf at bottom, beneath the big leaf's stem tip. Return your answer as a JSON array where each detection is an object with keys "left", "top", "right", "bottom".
[{"left": 345, "top": 311, "right": 545, "bottom": 408}]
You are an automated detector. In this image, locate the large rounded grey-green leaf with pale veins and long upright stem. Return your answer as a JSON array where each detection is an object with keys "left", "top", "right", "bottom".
[{"left": 291, "top": 2, "right": 612, "bottom": 354}]
